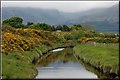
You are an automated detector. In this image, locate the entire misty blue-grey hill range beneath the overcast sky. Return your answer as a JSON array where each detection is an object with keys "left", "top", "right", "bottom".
[{"left": 2, "top": 4, "right": 119, "bottom": 32}]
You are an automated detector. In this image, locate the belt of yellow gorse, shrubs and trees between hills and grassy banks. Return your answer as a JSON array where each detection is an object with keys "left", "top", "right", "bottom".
[{"left": 2, "top": 17, "right": 119, "bottom": 53}]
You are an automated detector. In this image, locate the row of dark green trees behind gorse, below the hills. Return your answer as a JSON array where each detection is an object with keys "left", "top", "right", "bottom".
[{"left": 2, "top": 16, "right": 82, "bottom": 31}]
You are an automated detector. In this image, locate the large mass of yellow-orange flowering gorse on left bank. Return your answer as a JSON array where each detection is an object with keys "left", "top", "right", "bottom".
[{"left": 2, "top": 27, "right": 58, "bottom": 54}]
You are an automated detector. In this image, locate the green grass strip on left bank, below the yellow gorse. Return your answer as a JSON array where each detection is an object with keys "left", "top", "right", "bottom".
[{"left": 2, "top": 45, "right": 49, "bottom": 79}]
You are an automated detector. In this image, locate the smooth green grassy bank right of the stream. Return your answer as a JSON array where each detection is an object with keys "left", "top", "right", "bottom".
[{"left": 74, "top": 43, "right": 119, "bottom": 75}]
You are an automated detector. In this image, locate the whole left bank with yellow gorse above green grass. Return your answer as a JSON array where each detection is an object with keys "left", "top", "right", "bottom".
[{"left": 2, "top": 26, "right": 75, "bottom": 79}]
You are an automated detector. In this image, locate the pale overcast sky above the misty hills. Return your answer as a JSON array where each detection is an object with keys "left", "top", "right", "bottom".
[{"left": 2, "top": 1, "right": 119, "bottom": 12}]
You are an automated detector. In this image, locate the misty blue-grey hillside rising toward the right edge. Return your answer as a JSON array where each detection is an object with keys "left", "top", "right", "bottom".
[{"left": 64, "top": 5, "right": 119, "bottom": 32}]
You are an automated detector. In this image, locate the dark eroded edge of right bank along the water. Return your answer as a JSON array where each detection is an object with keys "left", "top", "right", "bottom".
[{"left": 73, "top": 44, "right": 120, "bottom": 79}]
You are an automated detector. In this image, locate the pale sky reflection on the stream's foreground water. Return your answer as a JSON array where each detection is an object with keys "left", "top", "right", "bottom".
[{"left": 36, "top": 60, "right": 97, "bottom": 78}]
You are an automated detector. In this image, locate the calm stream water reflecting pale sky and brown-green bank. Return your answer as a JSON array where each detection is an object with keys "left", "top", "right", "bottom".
[{"left": 36, "top": 48, "right": 97, "bottom": 79}]
